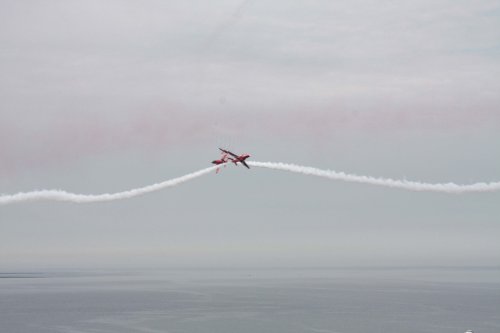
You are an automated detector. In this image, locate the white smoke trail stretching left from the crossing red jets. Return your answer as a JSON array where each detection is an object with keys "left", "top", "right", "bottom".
[{"left": 0, "top": 166, "right": 217, "bottom": 205}]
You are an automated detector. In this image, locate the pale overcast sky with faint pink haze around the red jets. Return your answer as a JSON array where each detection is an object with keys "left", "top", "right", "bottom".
[{"left": 0, "top": 0, "right": 500, "bottom": 270}]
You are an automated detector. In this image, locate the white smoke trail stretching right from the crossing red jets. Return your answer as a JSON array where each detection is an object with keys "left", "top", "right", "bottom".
[{"left": 247, "top": 162, "right": 500, "bottom": 194}]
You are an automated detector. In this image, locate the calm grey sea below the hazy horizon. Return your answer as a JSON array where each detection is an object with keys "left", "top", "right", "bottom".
[{"left": 0, "top": 267, "right": 500, "bottom": 333}]
